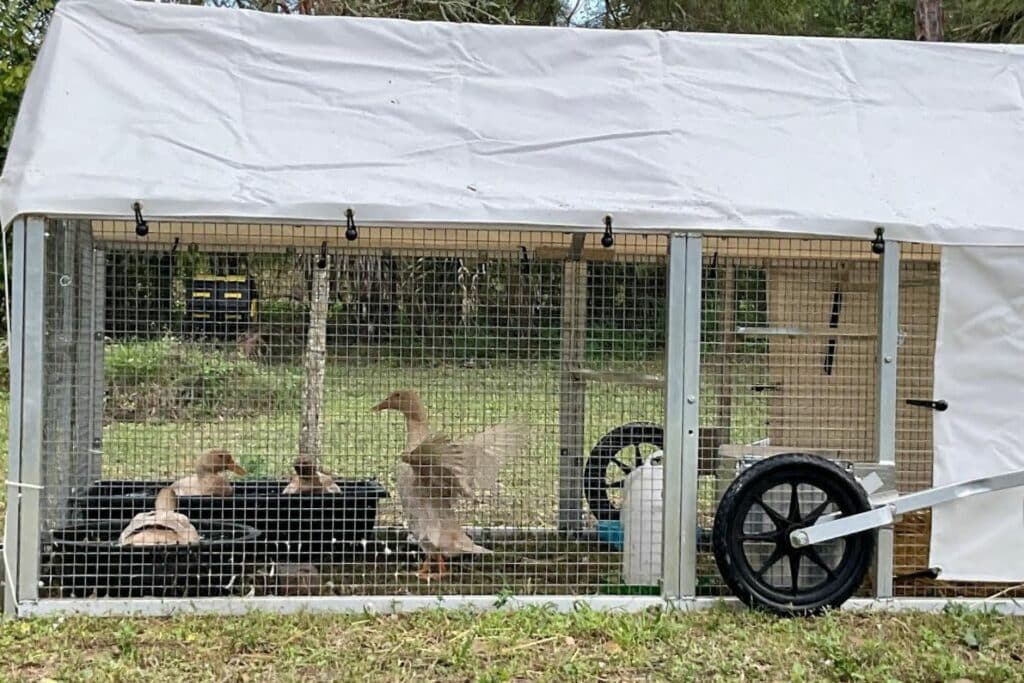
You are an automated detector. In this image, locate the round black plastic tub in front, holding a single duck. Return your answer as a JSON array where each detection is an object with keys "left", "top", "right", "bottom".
[{"left": 44, "top": 521, "right": 259, "bottom": 598}]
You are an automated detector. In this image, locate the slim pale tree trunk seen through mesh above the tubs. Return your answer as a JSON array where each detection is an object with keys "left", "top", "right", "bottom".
[{"left": 299, "top": 256, "right": 331, "bottom": 462}]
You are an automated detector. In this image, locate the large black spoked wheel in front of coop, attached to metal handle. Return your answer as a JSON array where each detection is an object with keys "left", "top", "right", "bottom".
[{"left": 712, "top": 454, "right": 874, "bottom": 615}]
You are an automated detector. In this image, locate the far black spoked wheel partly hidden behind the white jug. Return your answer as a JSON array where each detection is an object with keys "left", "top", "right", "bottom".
[{"left": 583, "top": 422, "right": 665, "bottom": 521}]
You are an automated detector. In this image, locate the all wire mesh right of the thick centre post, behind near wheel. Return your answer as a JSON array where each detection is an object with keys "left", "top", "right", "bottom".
[{"left": 698, "top": 239, "right": 1019, "bottom": 597}]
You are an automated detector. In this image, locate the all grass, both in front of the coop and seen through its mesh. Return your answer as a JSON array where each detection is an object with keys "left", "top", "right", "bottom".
[{"left": 0, "top": 356, "right": 1024, "bottom": 683}]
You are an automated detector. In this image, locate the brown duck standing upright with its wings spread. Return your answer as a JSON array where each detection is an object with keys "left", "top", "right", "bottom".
[{"left": 373, "top": 390, "right": 526, "bottom": 579}]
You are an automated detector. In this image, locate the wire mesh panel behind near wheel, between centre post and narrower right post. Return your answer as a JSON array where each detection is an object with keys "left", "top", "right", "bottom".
[{"left": 698, "top": 239, "right": 879, "bottom": 595}]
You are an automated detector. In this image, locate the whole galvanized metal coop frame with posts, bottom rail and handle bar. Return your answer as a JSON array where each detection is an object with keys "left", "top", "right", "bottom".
[{"left": 4, "top": 222, "right": 1024, "bottom": 616}]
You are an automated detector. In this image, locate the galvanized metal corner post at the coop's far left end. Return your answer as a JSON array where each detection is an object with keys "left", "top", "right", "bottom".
[{"left": 4, "top": 216, "right": 48, "bottom": 613}]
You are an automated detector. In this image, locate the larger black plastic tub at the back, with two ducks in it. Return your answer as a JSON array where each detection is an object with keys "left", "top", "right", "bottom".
[{"left": 72, "top": 479, "right": 388, "bottom": 562}]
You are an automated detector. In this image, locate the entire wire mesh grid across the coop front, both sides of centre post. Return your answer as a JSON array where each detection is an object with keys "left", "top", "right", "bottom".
[{"left": 18, "top": 221, "right": 1024, "bottom": 597}]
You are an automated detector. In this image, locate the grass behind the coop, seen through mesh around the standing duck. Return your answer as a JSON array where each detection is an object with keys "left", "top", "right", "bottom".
[{"left": 88, "top": 364, "right": 662, "bottom": 526}]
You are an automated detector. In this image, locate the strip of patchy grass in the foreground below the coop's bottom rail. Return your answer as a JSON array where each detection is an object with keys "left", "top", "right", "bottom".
[{"left": 0, "top": 609, "right": 1024, "bottom": 683}]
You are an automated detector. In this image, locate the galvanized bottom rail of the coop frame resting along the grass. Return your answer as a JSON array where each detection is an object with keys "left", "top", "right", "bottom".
[{"left": 18, "top": 595, "right": 1024, "bottom": 616}]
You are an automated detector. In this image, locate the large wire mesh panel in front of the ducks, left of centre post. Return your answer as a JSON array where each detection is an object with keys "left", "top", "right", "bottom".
[{"left": 32, "top": 222, "right": 667, "bottom": 597}]
